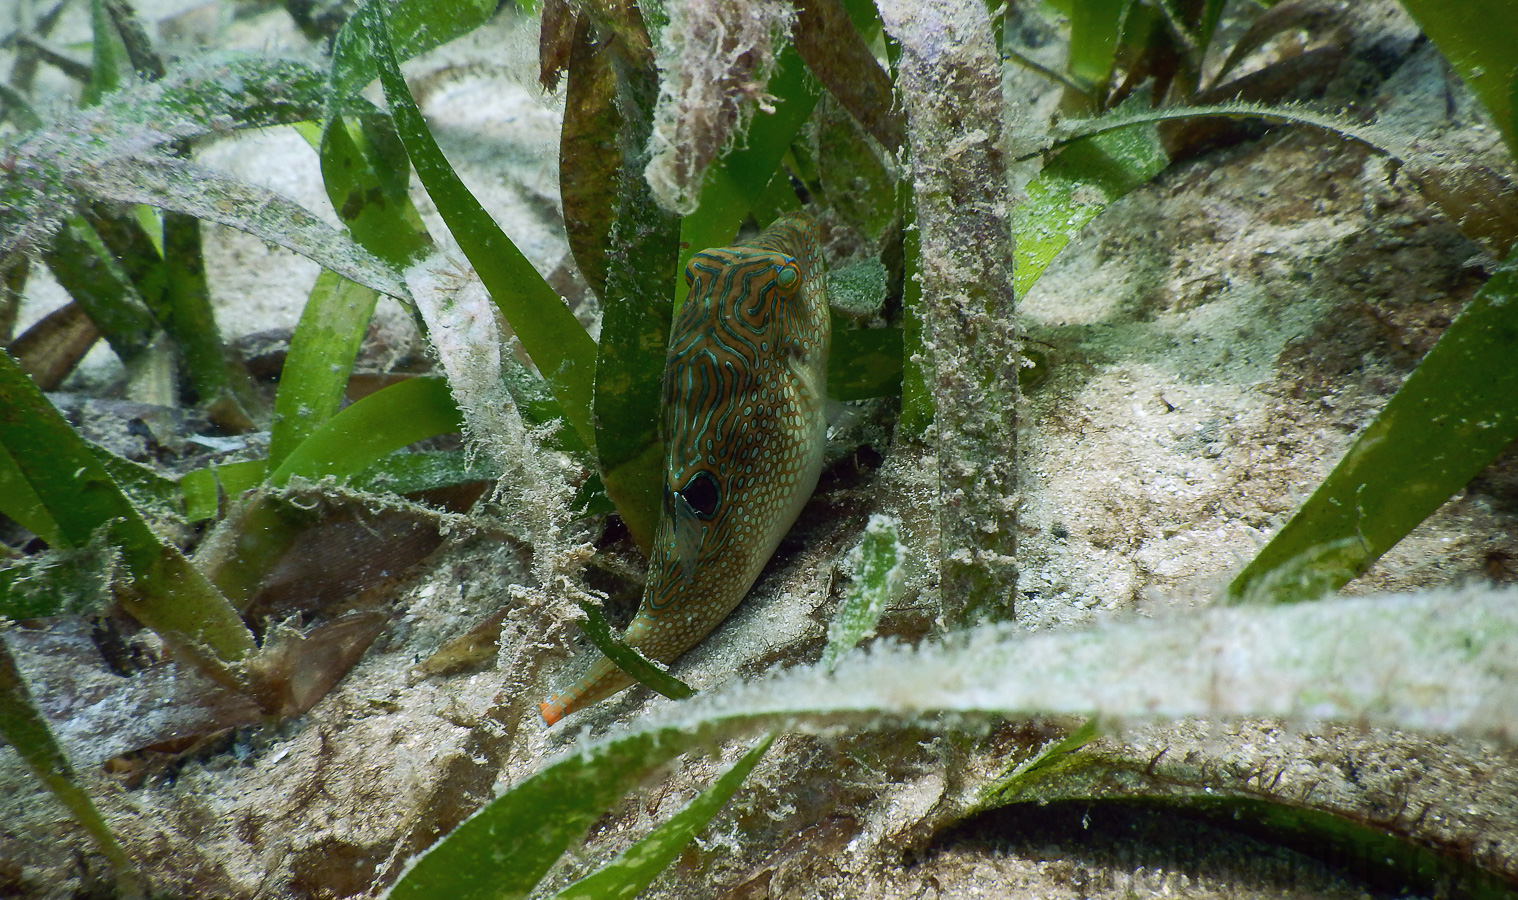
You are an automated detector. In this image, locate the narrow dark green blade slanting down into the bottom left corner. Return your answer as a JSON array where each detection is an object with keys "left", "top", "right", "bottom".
[{"left": 0, "top": 636, "right": 143, "bottom": 897}]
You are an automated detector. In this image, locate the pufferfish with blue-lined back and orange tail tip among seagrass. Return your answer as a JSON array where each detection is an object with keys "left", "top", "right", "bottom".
[{"left": 539, "top": 212, "right": 832, "bottom": 725}]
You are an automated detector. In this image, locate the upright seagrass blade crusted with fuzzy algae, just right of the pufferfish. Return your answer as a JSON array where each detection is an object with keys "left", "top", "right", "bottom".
[{"left": 879, "top": 0, "right": 1020, "bottom": 627}]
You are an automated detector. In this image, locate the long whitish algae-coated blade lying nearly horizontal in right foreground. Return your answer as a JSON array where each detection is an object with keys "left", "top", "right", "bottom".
[{"left": 584, "top": 587, "right": 1518, "bottom": 743}]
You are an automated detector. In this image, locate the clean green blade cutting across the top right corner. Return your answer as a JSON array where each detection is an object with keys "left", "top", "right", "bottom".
[{"left": 1403, "top": 0, "right": 1518, "bottom": 156}]
